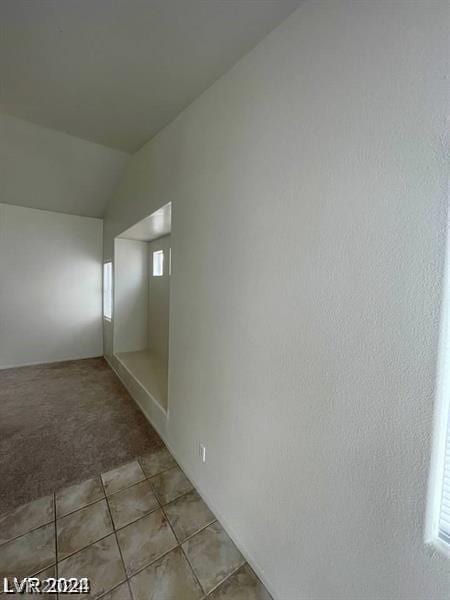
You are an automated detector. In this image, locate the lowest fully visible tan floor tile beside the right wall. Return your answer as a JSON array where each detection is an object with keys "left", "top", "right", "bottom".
[{"left": 183, "top": 522, "right": 245, "bottom": 593}]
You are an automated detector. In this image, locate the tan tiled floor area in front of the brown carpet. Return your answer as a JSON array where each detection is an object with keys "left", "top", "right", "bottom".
[{"left": 0, "top": 448, "right": 270, "bottom": 600}]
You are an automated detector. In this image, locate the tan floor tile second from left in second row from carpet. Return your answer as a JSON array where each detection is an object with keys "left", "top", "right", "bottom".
[{"left": 56, "top": 500, "right": 113, "bottom": 560}]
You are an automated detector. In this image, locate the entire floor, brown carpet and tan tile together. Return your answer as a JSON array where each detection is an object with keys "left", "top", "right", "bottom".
[{"left": 0, "top": 358, "right": 271, "bottom": 600}]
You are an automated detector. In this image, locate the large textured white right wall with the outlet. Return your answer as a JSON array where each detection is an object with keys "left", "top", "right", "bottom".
[{"left": 105, "top": 0, "right": 450, "bottom": 600}]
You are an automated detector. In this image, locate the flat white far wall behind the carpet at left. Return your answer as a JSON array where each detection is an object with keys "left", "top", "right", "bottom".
[{"left": 0, "top": 204, "right": 103, "bottom": 368}]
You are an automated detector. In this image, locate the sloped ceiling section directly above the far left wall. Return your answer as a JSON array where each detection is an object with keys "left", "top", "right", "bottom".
[{"left": 0, "top": 114, "right": 129, "bottom": 217}]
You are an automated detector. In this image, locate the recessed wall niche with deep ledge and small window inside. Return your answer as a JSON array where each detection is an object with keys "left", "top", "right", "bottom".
[{"left": 114, "top": 203, "right": 172, "bottom": 413}]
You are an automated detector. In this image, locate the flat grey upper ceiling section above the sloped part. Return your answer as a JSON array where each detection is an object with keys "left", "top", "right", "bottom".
[{"left": 0, "top": 0, "right": 299, "bottom": 152}]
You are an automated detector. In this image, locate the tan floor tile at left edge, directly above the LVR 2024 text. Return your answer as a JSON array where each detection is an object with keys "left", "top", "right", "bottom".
[{"left": 0, "top": 523, "right": 56, "bottom": 577}]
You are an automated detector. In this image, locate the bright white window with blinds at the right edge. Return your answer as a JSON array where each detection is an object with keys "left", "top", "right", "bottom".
[{"left": 426, "top": 226, "right": 450, "bottom": 557}]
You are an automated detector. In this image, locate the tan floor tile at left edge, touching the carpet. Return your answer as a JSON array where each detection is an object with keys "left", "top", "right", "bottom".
[{"left": 0, "top": 495, "right": 55, "bottom": 545}]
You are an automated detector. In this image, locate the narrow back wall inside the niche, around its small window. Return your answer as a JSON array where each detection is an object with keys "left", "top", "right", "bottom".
[{"left": 148, "top": 235, "right": 170, "bottom": 362}]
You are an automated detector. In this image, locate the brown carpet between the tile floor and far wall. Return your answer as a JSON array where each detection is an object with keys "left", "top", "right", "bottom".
[{"left": 0, "top": 358, "right": 162, "bottom": 514}]
